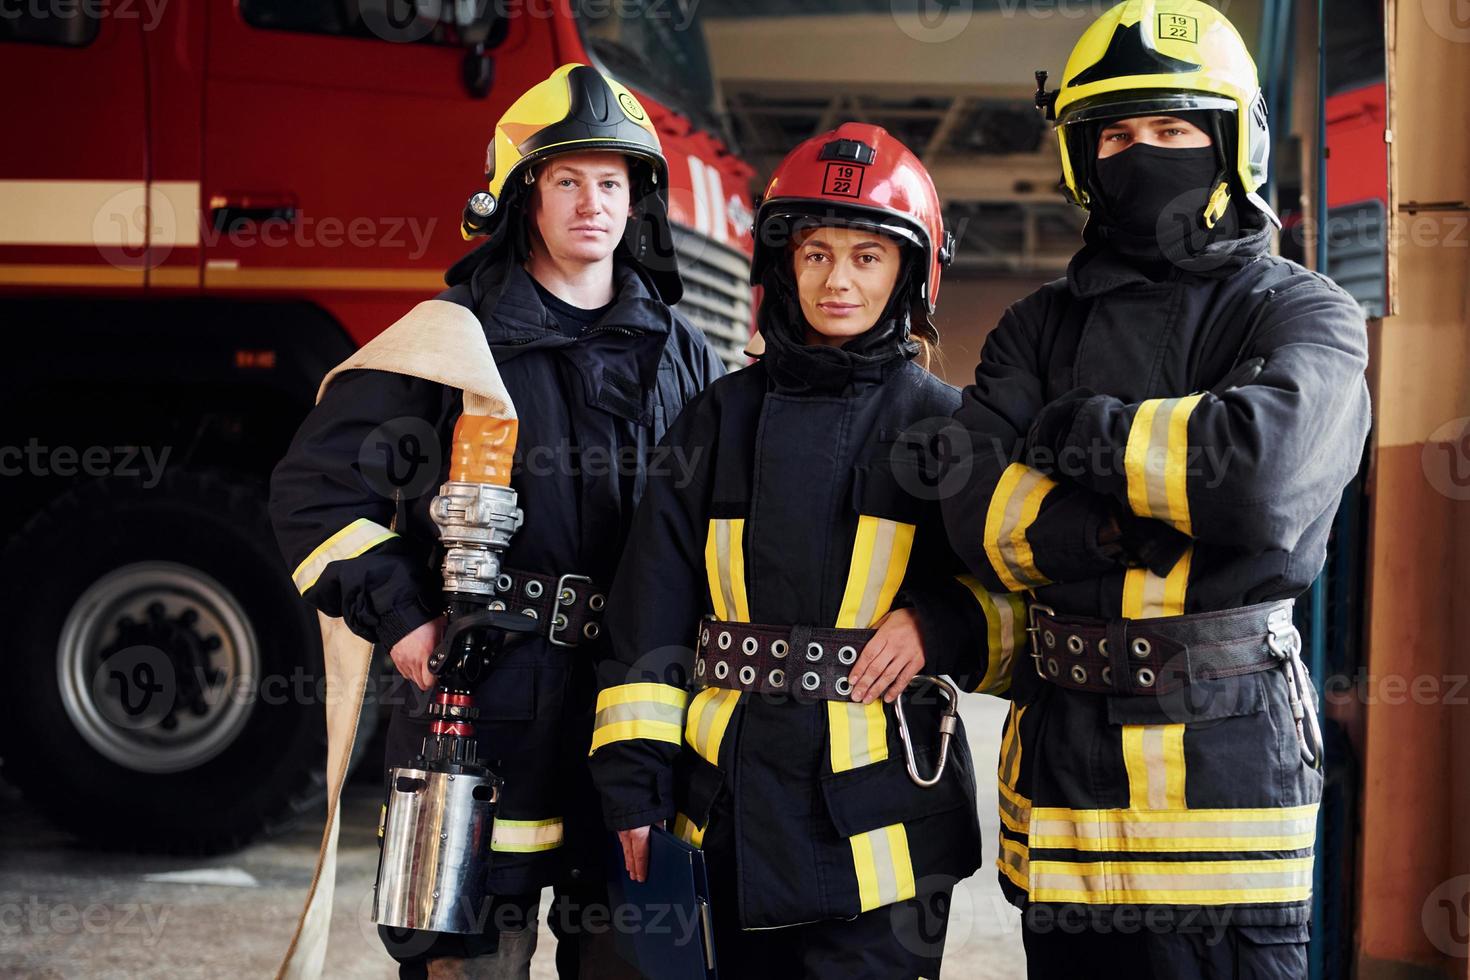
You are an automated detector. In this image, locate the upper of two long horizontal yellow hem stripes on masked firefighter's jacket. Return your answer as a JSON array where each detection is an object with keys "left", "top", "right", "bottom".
[{"left": 1030, "top": 804, "right": 1317, "bottom": 854}]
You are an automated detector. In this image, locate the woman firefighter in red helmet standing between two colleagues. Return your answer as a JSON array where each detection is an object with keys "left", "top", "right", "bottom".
[{"left": 591, "top": 123, "right": 1022, "bottom": 977}]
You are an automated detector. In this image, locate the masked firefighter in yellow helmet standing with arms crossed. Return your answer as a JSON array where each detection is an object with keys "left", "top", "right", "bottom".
[{"left": 944, "top": 0, "right": 1369, "bottom": 977}]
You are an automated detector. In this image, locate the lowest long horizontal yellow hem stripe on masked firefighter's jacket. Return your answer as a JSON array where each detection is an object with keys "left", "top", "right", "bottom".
[{"left": 1029, "top": 858, "right": 1313, "bottom": 905}]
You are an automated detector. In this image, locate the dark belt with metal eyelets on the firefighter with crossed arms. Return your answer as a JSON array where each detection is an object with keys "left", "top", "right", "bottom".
[{"left": 1026, "top": 599, "right": 1299, "bottom": 695}]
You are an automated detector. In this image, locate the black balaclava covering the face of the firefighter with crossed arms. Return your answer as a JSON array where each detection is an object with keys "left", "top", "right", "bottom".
[{"left": 1091, "top": 113, "right": 1242, "bottom": 266}]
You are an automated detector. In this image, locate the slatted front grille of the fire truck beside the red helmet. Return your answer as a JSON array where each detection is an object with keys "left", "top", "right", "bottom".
[{"left": 673, "top": 228, "right": 751, "bottom": 370}]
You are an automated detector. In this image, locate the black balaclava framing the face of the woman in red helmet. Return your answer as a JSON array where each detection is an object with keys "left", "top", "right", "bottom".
[{"left": 756, "top": 245, "right": 928, "bottom": 394}]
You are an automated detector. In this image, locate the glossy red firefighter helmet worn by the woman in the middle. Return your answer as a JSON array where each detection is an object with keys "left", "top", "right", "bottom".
[{"left": 750, "top": 122, "right": 954, "bottom": 313}]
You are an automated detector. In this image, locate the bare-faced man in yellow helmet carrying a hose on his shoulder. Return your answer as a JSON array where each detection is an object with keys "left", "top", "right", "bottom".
[{"left": 270, "top": 65, "right": 723, "bottom": 977}]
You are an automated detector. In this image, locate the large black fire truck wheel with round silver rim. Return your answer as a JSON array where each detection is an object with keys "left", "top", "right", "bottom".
[{"left": 0, "top": 472, "right": 352, "bottom": 854}]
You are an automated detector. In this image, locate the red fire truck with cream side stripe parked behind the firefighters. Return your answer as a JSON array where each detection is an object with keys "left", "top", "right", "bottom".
[{"left": 0, "top": 0, "right": 751, "bottom": 851}]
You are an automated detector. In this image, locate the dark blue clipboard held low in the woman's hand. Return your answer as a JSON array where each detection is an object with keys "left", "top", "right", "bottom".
[{"left": 607, "top": 827, "right": 717, "bottom": 980}]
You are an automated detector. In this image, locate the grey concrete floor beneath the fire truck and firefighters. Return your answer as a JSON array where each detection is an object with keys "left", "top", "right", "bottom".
[{"left": 0, "top": 698, "right": 1025, "bottom": 980}]
